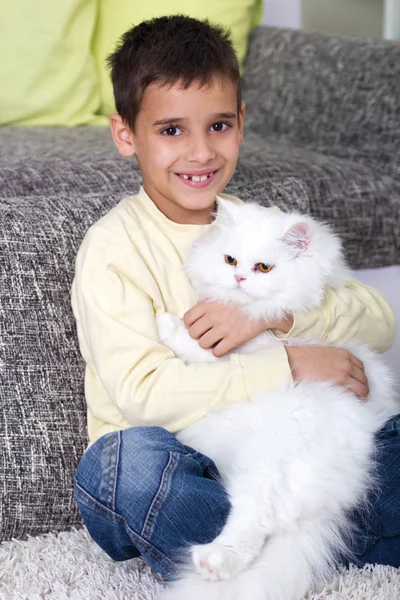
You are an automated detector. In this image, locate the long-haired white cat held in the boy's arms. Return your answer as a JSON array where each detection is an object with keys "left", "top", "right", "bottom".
[{"left": 157, "top": 199, "right": 399, "bottom": 600}]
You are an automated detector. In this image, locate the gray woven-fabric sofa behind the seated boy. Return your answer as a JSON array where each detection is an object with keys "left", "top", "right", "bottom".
[{"left": 0, "top": 27, "right": 400, "bottom": 540}]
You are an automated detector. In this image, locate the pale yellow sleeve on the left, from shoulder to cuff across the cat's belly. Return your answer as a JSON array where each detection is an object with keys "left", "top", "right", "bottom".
[{"left": 72, "top": 232, "right": 292, "bottom": 431}]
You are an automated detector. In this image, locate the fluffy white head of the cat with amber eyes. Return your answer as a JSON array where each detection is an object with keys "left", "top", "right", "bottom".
[{"left": 187, "top": 203, "right": 344, "bottom": 311}]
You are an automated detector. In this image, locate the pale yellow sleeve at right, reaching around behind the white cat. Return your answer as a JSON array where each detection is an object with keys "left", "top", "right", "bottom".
[{"left": 274, "top": 278, "right": 397, "bottom": 353}]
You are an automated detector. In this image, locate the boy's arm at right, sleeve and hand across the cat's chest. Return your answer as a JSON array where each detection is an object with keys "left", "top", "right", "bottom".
[{"left": 184, "top": 278, "right": 396, "bottom": 356}]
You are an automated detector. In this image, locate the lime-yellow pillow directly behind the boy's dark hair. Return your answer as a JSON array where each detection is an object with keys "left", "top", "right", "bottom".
[{"left": 93, "top": 0, "right": 262, "bottom": 115}]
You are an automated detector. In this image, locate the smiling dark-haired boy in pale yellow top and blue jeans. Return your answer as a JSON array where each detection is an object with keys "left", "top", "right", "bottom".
[{"left": 72, "top": 17, "right": 400, "bottom": 579}]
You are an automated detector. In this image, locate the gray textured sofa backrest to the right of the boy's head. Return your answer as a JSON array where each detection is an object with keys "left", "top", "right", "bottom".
[{"left": 244, "top": 27, "right": 400, "bottom": 173}]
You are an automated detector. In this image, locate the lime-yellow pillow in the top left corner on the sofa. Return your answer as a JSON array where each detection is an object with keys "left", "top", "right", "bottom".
[{"left": 0, "top": 0, "right": 107, "bottom": 125}]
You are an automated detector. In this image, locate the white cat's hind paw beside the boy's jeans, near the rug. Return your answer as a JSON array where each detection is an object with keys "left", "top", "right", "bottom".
[{"left": 192, "top": 542, "right": 242, "bottom": 581}]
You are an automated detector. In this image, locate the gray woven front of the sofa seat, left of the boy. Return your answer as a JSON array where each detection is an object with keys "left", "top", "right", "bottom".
[{"left": 0, "top": 193, "right": 141, "bottom": 539}]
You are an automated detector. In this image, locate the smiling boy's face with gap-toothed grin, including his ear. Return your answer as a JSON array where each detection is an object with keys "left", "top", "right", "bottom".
[{"left": 111, "top": 78, "right": 244, "bottom": 223}]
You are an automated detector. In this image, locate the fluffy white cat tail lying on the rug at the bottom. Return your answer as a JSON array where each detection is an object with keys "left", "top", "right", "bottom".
[{"left": 161, "top": 522, "right": 345, "bottom": 600}]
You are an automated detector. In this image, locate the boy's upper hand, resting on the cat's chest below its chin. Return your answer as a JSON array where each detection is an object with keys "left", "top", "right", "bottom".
[{"left": 183, "top": 301, "right": 293, "bottom": 358}]
